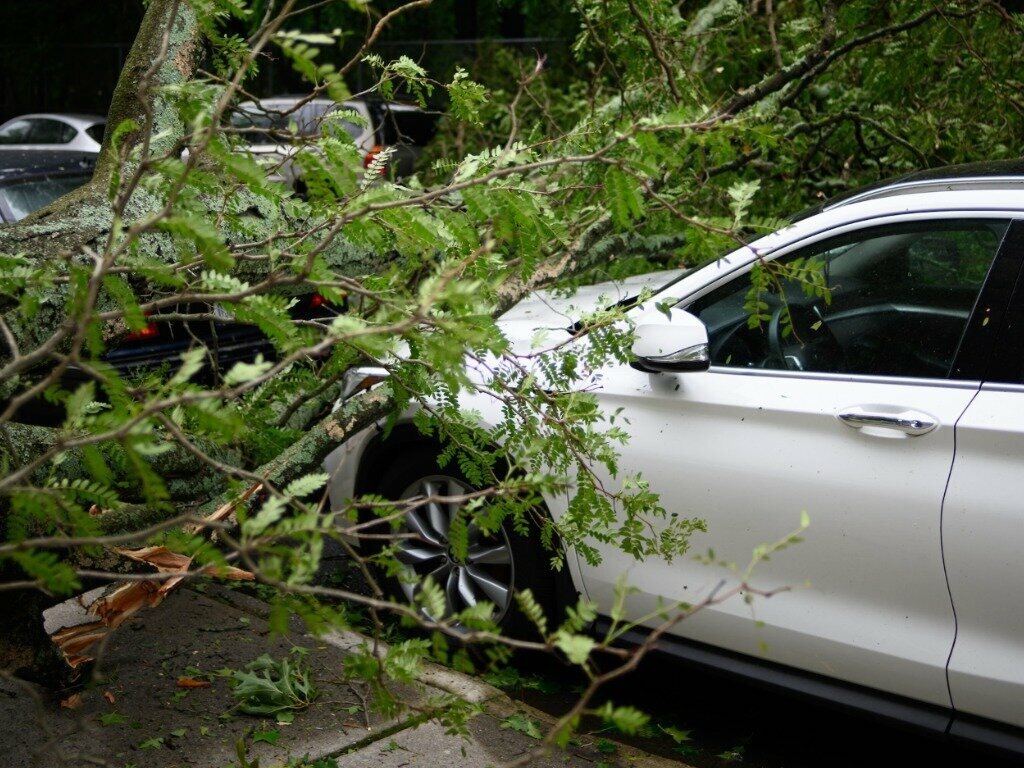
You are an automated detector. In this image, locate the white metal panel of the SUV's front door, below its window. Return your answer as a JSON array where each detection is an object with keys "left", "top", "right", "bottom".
[{"left": 583, "top": 358, "right": 977, "bottom": 707}]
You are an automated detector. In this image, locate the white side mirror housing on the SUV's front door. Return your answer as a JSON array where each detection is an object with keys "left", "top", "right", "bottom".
[{"left": 630, "top": 309, "right": 711, "bottom": 374}]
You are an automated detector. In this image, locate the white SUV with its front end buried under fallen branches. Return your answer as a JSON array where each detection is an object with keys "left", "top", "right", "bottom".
[{"left": 328, "top": 162, "right": 1024, "bottom": 753}]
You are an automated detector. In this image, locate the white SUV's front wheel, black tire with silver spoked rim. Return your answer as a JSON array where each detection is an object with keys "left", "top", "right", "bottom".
[{"left": 368, "top": 446, "right": 572, "bottom": 639}]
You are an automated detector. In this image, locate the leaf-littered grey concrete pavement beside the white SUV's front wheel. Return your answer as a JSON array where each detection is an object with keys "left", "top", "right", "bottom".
[{"left": 0, "top": 585, "right": 682, "bottom": 768}]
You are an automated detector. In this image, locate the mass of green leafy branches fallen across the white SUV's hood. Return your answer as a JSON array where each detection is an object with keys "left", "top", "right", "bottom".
[{"left": 0, "top": 0, "right": 1024, "bottom": 749}]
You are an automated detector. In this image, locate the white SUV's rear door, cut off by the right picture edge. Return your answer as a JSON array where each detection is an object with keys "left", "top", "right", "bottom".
[{"left": 942, "top": 222, "right": 1024, "bottom": 729}]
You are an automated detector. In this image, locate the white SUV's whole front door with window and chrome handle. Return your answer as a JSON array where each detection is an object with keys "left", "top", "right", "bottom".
[{"left": 582, "top": 214, "right": 1007, "bottom": 707}]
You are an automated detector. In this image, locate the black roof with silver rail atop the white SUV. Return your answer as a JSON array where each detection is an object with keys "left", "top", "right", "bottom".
[{"left": 790, "top": 158, "right": 1024, "bottom": 222}]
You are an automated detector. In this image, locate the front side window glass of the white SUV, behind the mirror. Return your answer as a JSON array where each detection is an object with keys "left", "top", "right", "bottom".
[{"left": 688, "top": 220, "right": 1008, "bottom": 378}]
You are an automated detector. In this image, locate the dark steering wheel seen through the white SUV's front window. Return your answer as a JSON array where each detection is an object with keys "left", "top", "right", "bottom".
[{"left": 768, "top": 303, "right": 846, "bottom": 373}]
